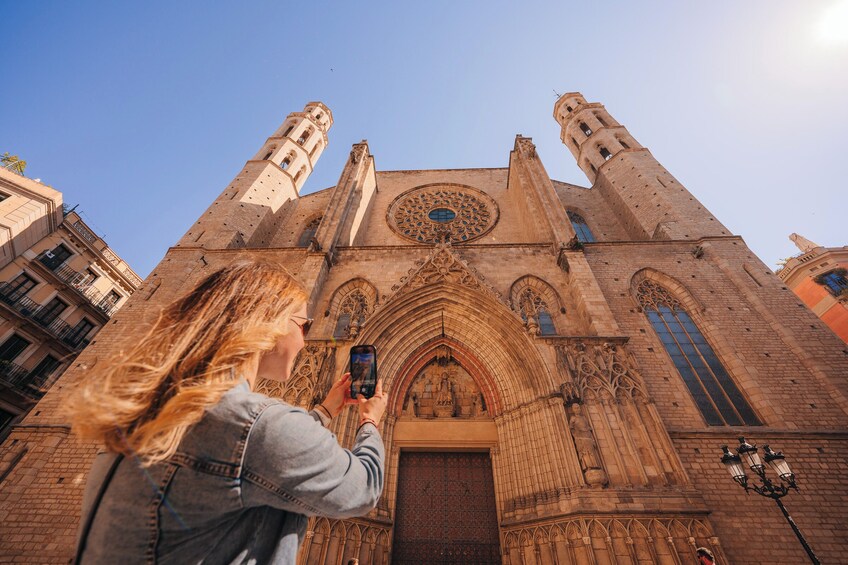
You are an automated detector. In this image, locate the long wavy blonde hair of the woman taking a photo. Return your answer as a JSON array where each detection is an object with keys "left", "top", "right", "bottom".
[{"left": 68, "top": 262, "right": 308, "bottom": 465}]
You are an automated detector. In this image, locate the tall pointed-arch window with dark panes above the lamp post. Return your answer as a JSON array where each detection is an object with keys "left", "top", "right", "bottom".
[{"left": 636, "top": 280, "right": 762, "bottom": 426}]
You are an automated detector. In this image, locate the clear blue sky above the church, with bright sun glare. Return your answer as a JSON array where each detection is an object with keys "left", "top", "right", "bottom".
[{"left": 0, "top": 0, "right": 848, "bottom": 276}]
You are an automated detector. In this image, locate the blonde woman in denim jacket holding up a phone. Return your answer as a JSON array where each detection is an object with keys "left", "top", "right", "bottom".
[{"left": 70, "top": 263, "right": 386, "bottom": 565}]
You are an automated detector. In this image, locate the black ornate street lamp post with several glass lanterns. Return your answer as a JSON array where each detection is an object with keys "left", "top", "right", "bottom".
[{"left": 721, "top": 437, "right": 821, "bottom": 565}]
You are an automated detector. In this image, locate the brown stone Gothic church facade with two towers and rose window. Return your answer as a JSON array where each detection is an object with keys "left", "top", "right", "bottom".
[{"left": 0, "top": 93, "right": 848, "bottom": 565}]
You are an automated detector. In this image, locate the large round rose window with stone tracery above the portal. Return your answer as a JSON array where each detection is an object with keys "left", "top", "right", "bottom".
[{"left": 386, "top": 184, "right": 498, "bottom": 243}]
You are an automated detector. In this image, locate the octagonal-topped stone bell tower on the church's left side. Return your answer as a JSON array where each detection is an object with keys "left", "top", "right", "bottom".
[{"left": 177, "top": 102, "right": 333, "bottom": 249}]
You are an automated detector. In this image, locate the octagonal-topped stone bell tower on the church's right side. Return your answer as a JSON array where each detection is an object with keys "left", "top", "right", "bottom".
[{"left": 554, "top": 92, "right": 730, "bottom": 240}]
